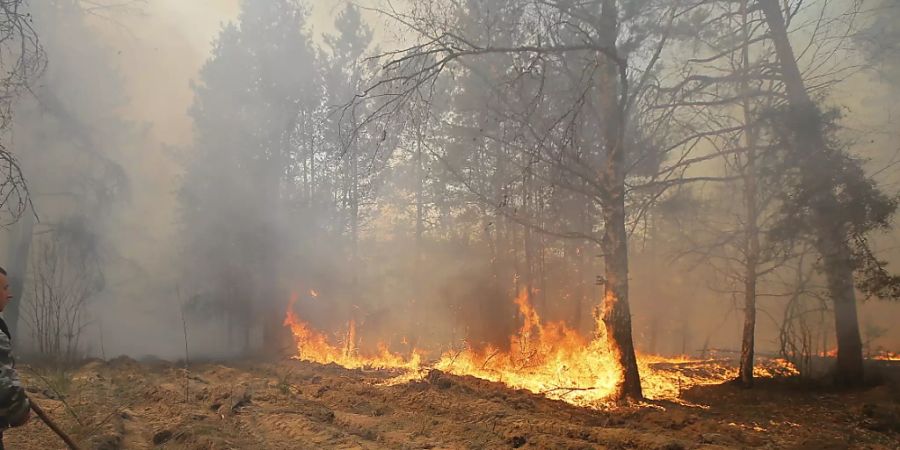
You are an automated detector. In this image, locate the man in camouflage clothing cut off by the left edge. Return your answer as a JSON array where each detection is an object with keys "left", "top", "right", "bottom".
[{"left": 0, "top": 267, "right": 31, "bottom": 450}]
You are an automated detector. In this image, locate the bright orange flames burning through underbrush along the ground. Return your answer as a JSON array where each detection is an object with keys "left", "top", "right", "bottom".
[{"left": 284, "top": 292, "right": 796, "bottom": 407}]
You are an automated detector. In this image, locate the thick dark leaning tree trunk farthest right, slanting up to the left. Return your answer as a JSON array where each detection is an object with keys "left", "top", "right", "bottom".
[{"left": 758, "top": 0, "right": 863, "bottom": 385}]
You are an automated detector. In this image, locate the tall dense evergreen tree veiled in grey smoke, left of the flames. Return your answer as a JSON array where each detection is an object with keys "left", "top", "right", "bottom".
[{"left": 181, "top": 0, "right": 320, "bottom": 350}]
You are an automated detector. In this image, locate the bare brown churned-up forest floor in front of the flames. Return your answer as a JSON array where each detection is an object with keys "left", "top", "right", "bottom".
[{"left": 5, "top": 358, "right": 900, "bottom": 450}]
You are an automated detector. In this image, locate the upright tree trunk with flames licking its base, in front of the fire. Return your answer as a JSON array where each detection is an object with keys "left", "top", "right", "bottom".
[{"left": 599, "top": 0, "right": 643, "bottom": 400}]
